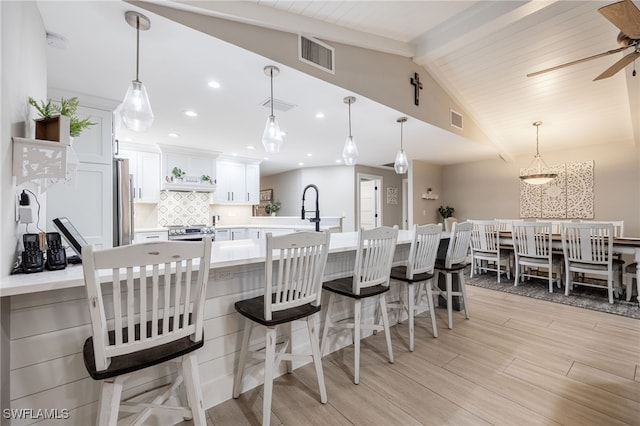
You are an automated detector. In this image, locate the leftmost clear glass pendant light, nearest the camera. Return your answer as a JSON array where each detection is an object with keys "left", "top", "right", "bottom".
[{"left": 120, "top": 11, "right": 153, "bottom": 132}]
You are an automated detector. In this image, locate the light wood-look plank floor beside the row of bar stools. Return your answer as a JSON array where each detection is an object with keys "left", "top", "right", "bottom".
[{"left": 202, "top": 286, "right": 640, "bottom": 426}]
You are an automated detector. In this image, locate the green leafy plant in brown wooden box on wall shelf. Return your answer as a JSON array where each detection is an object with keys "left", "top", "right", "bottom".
[{"left": 29, "top": 97, "right": 96, "bottom": 143}]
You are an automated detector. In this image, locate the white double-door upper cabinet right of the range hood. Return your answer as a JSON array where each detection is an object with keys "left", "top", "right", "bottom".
[{"left": 214, "top": 157, "right": 260, "bottom": 204}]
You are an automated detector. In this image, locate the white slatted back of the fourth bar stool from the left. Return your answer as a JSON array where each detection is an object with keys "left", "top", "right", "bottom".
[{"left": 407, "top": 223, "right": 442, "bottom": 279}]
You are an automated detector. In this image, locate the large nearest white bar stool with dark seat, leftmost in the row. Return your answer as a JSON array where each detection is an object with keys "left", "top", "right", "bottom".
[{"left": 82, "top": 237, "right": 211, "bottom": 425}]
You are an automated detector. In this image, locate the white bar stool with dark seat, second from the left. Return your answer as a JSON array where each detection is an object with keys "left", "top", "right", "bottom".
[{"left": 233, "top": 231, "right": 330, "bottom": 426}]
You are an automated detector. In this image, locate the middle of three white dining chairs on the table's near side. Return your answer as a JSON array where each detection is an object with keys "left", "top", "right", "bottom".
[{"left": 511, "top": 222, "right": 563, "bottom": 293}]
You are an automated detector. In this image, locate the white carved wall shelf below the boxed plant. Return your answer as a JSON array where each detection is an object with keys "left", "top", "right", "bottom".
[{"left": 12, "top": 137, "right": 69, "bottom": 185}]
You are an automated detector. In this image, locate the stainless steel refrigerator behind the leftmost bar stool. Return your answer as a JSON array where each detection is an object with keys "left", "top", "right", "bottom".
[{"left": 113, "top": 158, "right": 133, "bottom": 247}]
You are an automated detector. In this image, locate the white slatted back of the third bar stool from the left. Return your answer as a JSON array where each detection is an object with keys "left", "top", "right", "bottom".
[{"left": 352, "top": 226, "right": 398, "bottom": 294}]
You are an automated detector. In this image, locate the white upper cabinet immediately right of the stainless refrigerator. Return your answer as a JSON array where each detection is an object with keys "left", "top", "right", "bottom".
[{"left": 119, "top": 149, "right": 160, "bottom": 203}]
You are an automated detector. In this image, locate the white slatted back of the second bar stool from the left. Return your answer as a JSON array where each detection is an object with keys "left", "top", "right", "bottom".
[{"left": 264, "top": 231, "right": 330, "bottom": 320}]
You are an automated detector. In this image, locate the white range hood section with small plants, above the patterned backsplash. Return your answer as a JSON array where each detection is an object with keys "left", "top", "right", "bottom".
[{"left": 160, "top": 145, "right": 218, "bottom": 192}]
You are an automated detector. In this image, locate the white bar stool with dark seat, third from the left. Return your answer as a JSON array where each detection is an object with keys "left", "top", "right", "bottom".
[{"left": 321, "top": 225, "right": 398, "bottom": 385}]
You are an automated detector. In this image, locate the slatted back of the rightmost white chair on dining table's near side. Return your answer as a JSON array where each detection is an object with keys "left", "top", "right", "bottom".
[{"left": 562, "top": 222, "right": 615, "bottom": 266}]
